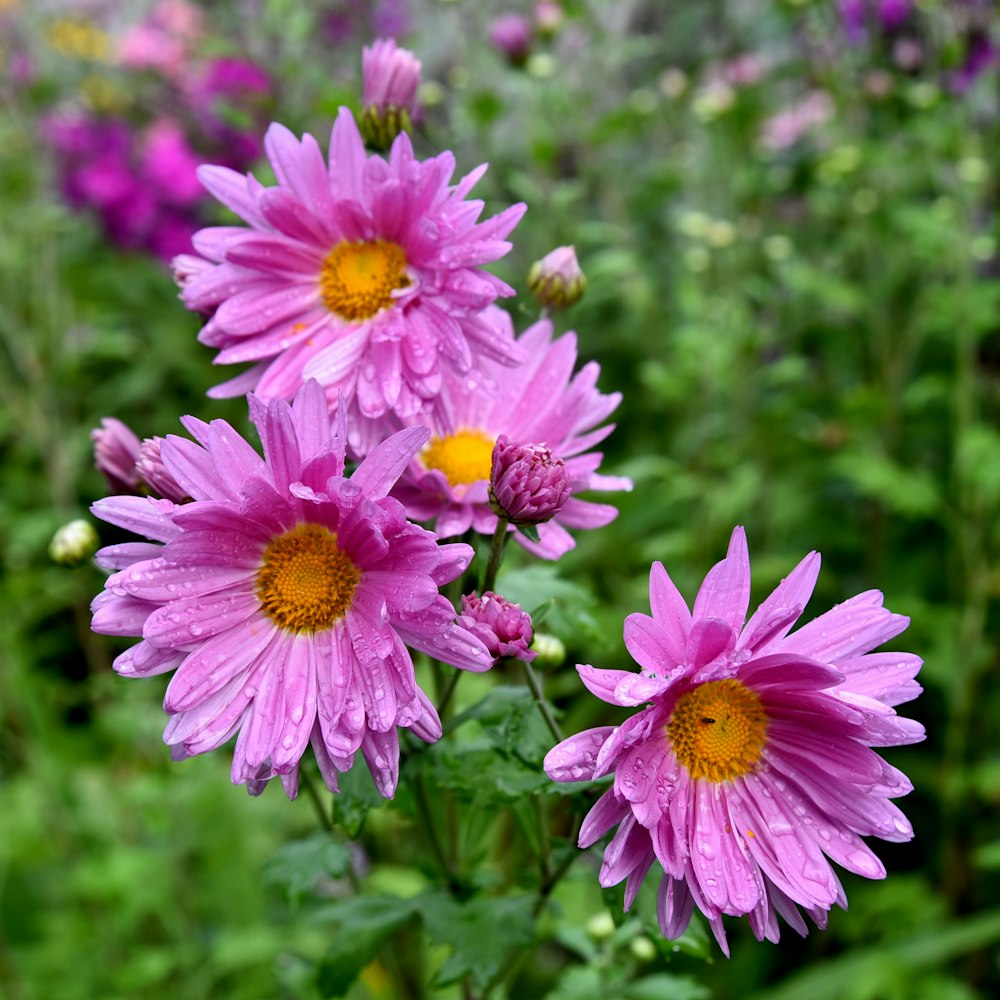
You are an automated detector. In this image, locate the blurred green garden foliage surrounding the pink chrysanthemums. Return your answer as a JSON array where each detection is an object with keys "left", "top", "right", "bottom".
[{"left": 0, "top": 0, "right": 1000, "bottom": 1000}]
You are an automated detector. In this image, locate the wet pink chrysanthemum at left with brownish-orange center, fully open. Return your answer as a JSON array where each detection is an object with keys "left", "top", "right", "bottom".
[{"left": 93, "top": 382, "right": 492, "bottom": 797}]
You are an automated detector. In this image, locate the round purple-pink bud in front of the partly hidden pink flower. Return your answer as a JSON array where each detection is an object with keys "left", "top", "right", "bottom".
[{"left": 490, "top": 434, "right": 570, "bottom": 526}]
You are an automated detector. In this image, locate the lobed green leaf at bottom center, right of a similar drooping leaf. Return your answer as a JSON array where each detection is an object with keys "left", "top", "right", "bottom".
[{"left": 416, "top": 894, "right": 535, "bottom": 989}]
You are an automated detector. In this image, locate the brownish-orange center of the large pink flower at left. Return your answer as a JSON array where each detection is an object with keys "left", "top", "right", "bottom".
[{"left": 257, "top": 524, "right": 360, "bottom": 632}]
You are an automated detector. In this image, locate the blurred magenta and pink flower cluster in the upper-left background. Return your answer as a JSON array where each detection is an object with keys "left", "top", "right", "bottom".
[{"left": 43, "top": 0, "right": 271, "bottom": 261}]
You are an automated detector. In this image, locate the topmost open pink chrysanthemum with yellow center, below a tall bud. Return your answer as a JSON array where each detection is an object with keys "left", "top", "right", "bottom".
[{"left": 182, "top": 108, "right": 524, "bottom": 417}]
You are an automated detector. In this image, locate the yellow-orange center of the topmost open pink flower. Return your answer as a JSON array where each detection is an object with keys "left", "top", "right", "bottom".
[{"left": 319, "top": 240, "right": 410, "bottom": 320}]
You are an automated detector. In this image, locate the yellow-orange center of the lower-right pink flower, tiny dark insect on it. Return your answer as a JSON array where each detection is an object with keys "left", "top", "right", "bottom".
[{"left": 667, "top": 679, "right": 767, "bottom": 782}]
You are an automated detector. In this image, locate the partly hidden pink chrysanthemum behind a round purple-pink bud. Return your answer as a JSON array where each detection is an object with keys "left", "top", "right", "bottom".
[{"left": 393, "top": 309, "right": 632, "bottom": 559}]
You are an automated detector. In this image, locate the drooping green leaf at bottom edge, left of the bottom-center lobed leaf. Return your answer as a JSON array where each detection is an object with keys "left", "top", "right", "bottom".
[{"left": 316, "top": 896, "right": 416, "bottom": 997}]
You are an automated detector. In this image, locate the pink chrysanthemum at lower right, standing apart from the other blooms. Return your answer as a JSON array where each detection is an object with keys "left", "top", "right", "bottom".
[{"left": 545, "top": 528, "right": 924, "bottom": 955}]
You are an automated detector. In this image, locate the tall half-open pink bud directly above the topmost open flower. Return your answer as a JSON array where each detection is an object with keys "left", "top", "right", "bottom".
[{"left": 359, "top": 38, "right": 420, "bottom": 151}]
